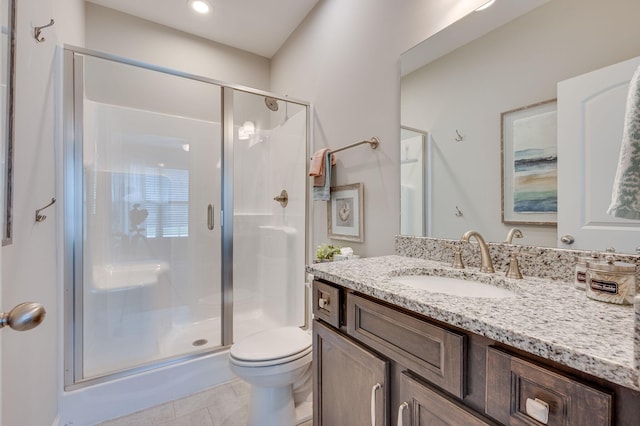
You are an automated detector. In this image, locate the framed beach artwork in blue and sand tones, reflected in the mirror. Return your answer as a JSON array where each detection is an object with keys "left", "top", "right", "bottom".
[{"left": 501, "top": 99, "right": 558, "bottom": 225}]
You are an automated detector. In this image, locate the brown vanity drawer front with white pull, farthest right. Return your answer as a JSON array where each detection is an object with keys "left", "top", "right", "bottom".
[{"left": 485, "top": 348, "right": 613, "bottom": 426}]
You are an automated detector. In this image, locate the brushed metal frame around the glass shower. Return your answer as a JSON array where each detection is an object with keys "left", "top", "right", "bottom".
[{"left": 57, "top": 45, "right": 313, "bottom": 390}]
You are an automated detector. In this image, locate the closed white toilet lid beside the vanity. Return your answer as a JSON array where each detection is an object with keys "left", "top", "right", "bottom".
[{"left": 230, "top": 327, "right": 311, "bottom": 362}]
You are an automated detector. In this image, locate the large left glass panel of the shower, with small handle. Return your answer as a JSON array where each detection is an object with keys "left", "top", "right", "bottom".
[{"left": 74, "top": 55, "right": 222, "bottom": 380}]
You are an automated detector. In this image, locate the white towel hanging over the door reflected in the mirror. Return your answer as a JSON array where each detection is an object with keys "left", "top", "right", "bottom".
[{"left": 607, "top": 67, "right": 640, "bottom": 219}]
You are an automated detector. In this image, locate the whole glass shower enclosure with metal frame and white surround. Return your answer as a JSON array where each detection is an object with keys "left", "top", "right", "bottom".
[{"left": 63, "top": 48, "right": 310, "bottom": 390}]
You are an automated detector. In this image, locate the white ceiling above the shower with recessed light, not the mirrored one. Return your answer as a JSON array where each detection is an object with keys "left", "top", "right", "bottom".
[{"left": 88, "top": 0, "right": 319, "bottom": 58}]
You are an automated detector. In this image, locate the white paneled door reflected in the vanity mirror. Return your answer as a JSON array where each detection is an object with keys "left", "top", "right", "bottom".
[{"left": 558, "top": 57, "right": 640, "bottom": 253}]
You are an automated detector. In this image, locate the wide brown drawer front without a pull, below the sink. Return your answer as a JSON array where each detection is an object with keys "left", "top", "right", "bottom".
[{"left": 346, "top": 293, "right": 465, "bottom": 398}]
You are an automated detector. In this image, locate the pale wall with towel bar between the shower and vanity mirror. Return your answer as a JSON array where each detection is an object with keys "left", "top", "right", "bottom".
[{"left": 271, "top": 0, "right": 484, "bottom": 256}]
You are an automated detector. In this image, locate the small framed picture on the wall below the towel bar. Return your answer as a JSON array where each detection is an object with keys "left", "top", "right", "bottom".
[{"left": 327, "top": 183, "right": 364, "bottom": 242}]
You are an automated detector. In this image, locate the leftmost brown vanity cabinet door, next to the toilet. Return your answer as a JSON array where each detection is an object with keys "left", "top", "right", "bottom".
[{"left": 313, "top": 320, "right": 389, "bottom": 426}]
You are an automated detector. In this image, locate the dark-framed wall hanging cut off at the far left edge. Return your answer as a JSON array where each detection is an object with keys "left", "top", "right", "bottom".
[{"left": 0, "top": 0, "right": 15, "bottom": 245}]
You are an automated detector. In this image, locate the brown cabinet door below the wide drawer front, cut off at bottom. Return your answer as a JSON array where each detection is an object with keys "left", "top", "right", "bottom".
[{"left": 398, "top": 372, "right": 496, "bottom": 426}]
